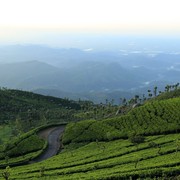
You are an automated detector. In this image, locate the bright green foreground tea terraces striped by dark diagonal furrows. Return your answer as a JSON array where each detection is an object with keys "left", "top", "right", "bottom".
[{"left": 5, "top": 134, "right": 180, "bottom": 180}]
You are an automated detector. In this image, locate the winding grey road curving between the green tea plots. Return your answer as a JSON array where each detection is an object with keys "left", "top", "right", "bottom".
[{"left": 30, "top": 125, "right": 65, "bottom": 163}]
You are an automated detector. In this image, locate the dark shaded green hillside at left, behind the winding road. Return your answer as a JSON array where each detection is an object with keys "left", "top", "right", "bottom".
[{"left": 0, "top": 88, "right": 81, "bottom": 135}]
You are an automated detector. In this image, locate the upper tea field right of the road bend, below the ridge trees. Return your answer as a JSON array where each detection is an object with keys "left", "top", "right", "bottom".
[{"left": 63, "top": 98, "right": 180, "bottom": 144}]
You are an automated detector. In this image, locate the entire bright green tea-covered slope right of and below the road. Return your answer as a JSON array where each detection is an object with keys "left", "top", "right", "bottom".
[{"left": 2, "top": 89, "right": 180, "bottom": 180}]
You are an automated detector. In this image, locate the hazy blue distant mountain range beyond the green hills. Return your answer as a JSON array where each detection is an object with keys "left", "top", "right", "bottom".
[{"left": 0, "top": 45, "right": 180, "bottom": 103}]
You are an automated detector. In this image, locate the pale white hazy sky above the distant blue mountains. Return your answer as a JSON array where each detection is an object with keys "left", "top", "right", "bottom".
[{"left": 0, "top": 0, "right": 180, "bottom": 45}]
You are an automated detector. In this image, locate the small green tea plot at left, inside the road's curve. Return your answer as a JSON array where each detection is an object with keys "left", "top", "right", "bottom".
[{"left": 0, "top": 129, "right": 47, "bottom": 167}]
